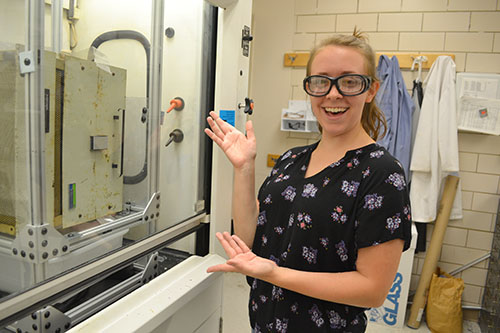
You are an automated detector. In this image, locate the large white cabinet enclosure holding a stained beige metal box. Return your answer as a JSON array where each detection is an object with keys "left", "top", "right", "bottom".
[{"left": 0, "top": 0, "right": 252, "bottom": 333}]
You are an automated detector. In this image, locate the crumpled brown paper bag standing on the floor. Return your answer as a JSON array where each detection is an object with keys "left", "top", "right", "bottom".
[{"left": 426, "top": 267, "right": 464, "bottom": 333}]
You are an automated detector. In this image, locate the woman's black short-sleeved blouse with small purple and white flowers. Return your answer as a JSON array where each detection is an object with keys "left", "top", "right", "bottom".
[{"left": 248, "top": 143, "right": 411, "bottom": 333}]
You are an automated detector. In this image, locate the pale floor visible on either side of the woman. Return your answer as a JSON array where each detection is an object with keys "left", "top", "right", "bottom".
[{"left": 223, "top": 273, "right": 481, "bottom": 333}]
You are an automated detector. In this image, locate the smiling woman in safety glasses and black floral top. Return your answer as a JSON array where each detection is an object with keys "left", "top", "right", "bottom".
[{"left": 205, "top": 32, "right": 411, "bottom": 332}]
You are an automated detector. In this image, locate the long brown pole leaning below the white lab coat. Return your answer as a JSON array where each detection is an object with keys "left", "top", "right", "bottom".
[{"left": 407, "top": 175, "right": 459, "bottom": 328}]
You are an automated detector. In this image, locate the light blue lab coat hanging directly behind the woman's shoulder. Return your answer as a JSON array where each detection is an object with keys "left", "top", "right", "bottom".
[{"left": 375, "top": 55, "right": 415, "bottom": 179}]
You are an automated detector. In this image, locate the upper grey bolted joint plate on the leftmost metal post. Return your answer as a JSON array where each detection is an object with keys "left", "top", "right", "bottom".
[{"left": 11, "top": 224, "right": 69, "bottom": 264}]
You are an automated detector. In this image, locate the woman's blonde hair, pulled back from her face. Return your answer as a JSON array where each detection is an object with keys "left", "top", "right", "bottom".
[{"left": 306, "top": 28, "right": 387, "bottom": 141}]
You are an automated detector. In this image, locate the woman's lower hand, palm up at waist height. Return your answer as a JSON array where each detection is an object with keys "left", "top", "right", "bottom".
[{"left": 207, "top": 232, "right": 278, "bottom": 280}]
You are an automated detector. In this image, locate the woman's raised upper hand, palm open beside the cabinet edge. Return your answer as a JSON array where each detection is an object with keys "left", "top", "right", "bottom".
[{"left": 205, "top": 111, "right": 257, "bottom": 168}]
